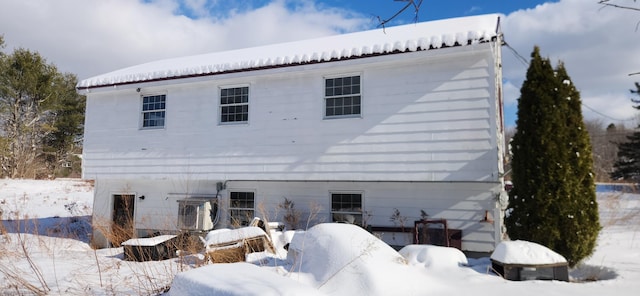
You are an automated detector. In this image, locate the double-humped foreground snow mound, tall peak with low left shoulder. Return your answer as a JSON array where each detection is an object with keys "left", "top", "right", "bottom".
[{"left": 170, "top": 223, "right": 437, "bottom": 296}]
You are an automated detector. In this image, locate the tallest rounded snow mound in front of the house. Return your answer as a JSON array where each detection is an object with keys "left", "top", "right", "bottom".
[{"left": 287, "top": 223, "right": 424, "bottom": 295}]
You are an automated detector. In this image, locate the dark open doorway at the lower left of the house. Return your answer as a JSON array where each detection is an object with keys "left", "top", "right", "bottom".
[{"left": 109, "top": 194, "right": 135, "bottom": 247}]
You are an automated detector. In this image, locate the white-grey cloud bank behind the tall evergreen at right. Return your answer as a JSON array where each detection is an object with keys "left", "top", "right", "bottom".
[{"left": 502, "top": 0, "right": 640, "bottom": 123}]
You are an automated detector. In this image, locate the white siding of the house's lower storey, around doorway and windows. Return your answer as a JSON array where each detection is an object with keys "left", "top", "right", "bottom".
[{"left": 94, "top": 179, "right": 500, "bottom": 252}]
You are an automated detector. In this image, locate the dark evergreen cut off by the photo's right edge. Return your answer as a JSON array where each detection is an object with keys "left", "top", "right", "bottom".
[{"left": 611, "top": 82, "right": 640, "bottom": 181}]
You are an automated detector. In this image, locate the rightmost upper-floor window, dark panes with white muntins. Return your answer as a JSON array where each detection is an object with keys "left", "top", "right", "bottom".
[{"left": 324, "top": 76, "right": 361, "bottom": 118}]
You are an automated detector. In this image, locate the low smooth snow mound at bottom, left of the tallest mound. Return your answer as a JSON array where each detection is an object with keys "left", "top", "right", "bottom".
[{"left": 169, "top": 263, "right": 321, "bottom": 296}]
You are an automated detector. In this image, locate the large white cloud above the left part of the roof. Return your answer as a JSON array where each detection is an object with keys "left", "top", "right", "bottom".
[{"left": 0, "top": 0, "right": 369, "bottom": 79}]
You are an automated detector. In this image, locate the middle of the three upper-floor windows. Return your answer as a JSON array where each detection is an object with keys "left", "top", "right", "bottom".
[{"left": 220, "top": 86, "right": 249, "bottom": 123}]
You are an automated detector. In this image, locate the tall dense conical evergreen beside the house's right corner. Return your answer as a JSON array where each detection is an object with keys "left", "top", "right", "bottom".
[{"left": 505, "top": 47, "right": 600, "bottom": 266}]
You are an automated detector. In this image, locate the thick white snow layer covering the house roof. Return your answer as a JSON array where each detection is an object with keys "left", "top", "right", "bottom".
[{"left": 77, "top": 14, "right": 500, "bottom": 89}]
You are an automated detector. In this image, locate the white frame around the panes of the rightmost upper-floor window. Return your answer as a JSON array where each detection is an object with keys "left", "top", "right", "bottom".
[{"left": 322, "top": 73, "right": 363, "bottom": 119}]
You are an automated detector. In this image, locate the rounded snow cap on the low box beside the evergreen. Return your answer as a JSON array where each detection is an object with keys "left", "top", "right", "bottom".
[{"left": 491, "top": 240, "right": 567, "bottom": 265}]
